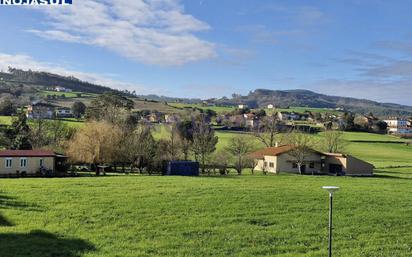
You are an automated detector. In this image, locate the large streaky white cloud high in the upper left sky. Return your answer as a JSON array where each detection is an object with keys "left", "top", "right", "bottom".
[{"left": 28, "top": 0, "right": 217, "bottom": 66}]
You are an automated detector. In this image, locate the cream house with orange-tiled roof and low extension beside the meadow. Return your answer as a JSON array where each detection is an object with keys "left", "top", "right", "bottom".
[{"left": 251, "top": 145, "right": 374, "bottom": 176}]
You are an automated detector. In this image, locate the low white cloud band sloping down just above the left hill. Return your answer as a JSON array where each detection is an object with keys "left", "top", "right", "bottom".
[{"left": 0, "top": 53, "right": 164, "bottom": 94}]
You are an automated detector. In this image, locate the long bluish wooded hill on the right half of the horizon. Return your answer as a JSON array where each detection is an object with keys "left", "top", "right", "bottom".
[{"left": 215, "top": 89, "right": 412, "bottom": 116}]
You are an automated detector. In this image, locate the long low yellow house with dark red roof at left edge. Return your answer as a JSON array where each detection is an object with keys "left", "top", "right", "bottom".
[{"left": 0, "top": 150, "right": 66, "bottom": 176}]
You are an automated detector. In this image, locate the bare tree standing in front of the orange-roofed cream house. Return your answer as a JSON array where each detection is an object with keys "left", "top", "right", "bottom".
[{"left": 287, "top": 131, "right": 314, "bottom": 175}]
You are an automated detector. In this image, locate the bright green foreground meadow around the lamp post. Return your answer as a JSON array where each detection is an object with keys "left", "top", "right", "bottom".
[{"left": 0, "top": 168, "right": 412, "bottom": 257}]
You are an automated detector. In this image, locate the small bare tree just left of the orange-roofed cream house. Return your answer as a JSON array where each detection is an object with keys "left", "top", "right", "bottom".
[{"left": 226, "top": 137, "right": 252, "bottom": 175}]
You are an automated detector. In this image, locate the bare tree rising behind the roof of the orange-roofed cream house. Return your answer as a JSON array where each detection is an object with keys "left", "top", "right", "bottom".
[{"left": 253, "top": 116, "right": 281, "bottom": 147}]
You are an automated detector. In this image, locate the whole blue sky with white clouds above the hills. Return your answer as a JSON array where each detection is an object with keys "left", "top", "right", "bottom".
[{"left": 0, "top": 0, "right": 412, "bottom": 105}]
